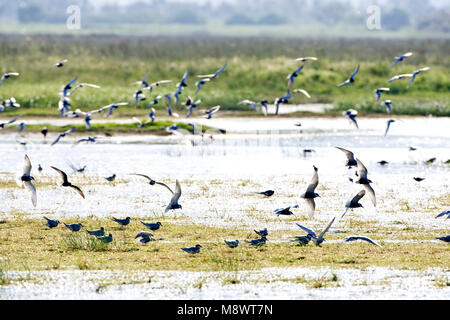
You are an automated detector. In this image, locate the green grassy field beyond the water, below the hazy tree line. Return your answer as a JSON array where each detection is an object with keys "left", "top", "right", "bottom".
[{"left": 0, "top": 35, "right": 450, "bottom": 118}]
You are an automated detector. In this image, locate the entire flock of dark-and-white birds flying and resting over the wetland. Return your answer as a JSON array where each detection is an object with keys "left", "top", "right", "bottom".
[{"left": 0, "top": 52, "right": 450, "bottom": 253}]
